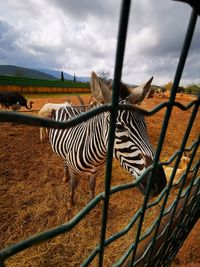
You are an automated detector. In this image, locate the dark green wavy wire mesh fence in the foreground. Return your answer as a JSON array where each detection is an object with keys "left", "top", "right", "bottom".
[{"left": 0, "top": 0, "right": 200, "bottom": 267}]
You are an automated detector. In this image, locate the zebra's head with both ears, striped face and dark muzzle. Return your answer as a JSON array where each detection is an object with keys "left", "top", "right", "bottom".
[{"left": 91, "top": 72, "right": 166, "bottom": 196}]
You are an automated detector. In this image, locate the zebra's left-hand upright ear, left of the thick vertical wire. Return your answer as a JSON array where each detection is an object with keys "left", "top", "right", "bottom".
[{"left": 91, "top": 71, "right": 111, "bottom": 103}]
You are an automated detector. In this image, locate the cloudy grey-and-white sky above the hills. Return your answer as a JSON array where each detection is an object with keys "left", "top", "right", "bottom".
[{"left": 0, "top": 0, "right": 200, "bottom": 85}]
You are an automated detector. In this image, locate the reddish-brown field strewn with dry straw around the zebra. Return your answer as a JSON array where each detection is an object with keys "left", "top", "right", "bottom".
[{"left": 0, "top": 95, "right": 200, "bottom": 267}]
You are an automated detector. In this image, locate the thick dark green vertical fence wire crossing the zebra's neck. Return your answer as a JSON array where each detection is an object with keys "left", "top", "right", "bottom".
[{"left": 99, "top": 0, "right": 131, "bottom": 266}]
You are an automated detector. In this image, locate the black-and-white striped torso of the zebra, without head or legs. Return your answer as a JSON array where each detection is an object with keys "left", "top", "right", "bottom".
[{"left": 49, "top": 107, "right": 109, "bottom": 176}]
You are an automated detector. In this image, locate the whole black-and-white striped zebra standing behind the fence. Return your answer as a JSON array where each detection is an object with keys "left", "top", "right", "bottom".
[{"left": 49, "top": 72, "right": 166, "bottom": 206}]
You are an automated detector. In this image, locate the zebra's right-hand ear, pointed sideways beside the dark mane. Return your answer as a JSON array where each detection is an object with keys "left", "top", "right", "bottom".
[{"left": 128, "top": 76, "right": 153, "bottom": 105}]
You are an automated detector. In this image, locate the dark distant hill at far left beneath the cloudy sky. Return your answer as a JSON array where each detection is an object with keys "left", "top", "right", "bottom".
[{"left": 0, "top": 65, "right": 56, "bottom": 80}]
